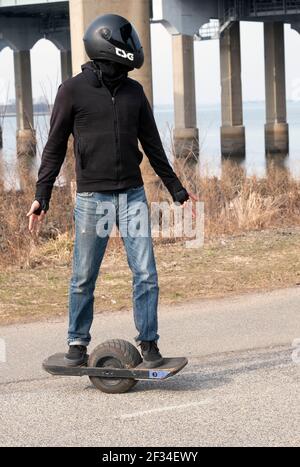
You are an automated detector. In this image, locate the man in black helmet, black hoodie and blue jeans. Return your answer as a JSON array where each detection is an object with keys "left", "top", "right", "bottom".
[{"left": 27, "top": 15, "right": 189, "bottom": 368}]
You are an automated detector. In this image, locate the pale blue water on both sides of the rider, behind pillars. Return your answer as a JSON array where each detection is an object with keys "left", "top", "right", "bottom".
[{"left": 0, "top": 102, "right": 300, "bottom": 185}]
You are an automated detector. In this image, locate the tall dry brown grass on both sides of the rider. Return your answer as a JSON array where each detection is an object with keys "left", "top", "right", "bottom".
[{"left": 0, "top": 156, "right": 300, "bottom": 268}]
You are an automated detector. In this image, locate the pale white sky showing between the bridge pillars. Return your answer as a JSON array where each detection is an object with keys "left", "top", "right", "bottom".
[{"left": 0, "top": 6, "right": 300, "bottom": 106}]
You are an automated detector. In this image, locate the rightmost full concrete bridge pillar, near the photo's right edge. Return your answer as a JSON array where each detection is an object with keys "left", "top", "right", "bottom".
[{"left": 264, "top": 22, "right": 289, "bottom": 154}]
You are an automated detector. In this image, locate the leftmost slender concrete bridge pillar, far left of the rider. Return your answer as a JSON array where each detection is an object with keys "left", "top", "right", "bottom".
[{"left": 14, "top": 50, "right": 36, "bottom": 185}]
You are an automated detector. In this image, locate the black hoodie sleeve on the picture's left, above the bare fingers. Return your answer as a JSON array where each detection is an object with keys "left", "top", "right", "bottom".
[{"left": 35, "top": 83, "right": 73, "bottom": 204}]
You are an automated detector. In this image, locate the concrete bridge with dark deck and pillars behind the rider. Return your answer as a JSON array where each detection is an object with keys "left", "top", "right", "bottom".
[{"left": 0, "top": 0, "right": 300, "bottom": 176}]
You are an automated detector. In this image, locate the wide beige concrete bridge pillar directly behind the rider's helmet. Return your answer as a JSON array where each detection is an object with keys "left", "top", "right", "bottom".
[{"left": 69, "top": 0, "right": 157, "bottom": 190}]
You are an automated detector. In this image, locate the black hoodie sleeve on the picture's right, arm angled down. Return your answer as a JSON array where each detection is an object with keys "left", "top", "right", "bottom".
[{"left": 138, "top": 91, "right": 189, "bottom": 204}]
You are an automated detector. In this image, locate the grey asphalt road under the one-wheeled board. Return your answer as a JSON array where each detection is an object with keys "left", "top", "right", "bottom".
[{"left": 0, "top": 288, "right": 300, "bottom": 447}]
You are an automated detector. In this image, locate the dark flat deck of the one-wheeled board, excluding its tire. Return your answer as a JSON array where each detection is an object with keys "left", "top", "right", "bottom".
[{"left": 43, "top": 353, "right": 188, "bottom": 380}]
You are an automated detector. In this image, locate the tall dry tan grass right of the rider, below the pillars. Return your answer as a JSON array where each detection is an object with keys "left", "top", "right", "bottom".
[{"left": 171, "top": 160, "right": 300, "bottom": 238}]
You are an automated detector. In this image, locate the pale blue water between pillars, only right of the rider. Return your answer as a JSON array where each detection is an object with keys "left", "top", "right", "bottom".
[{"left": 155, "top": 101, "right": 300, "bottom": 178}]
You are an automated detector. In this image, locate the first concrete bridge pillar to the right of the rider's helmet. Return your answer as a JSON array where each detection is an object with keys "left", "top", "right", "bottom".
[{"left": 172, "top": 34, "right": 199, "bottom": 161}]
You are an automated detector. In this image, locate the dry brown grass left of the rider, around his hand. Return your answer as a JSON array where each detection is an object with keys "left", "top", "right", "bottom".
[{"left": 0, "top": 139, "right": 73, "bottom": 268}]
